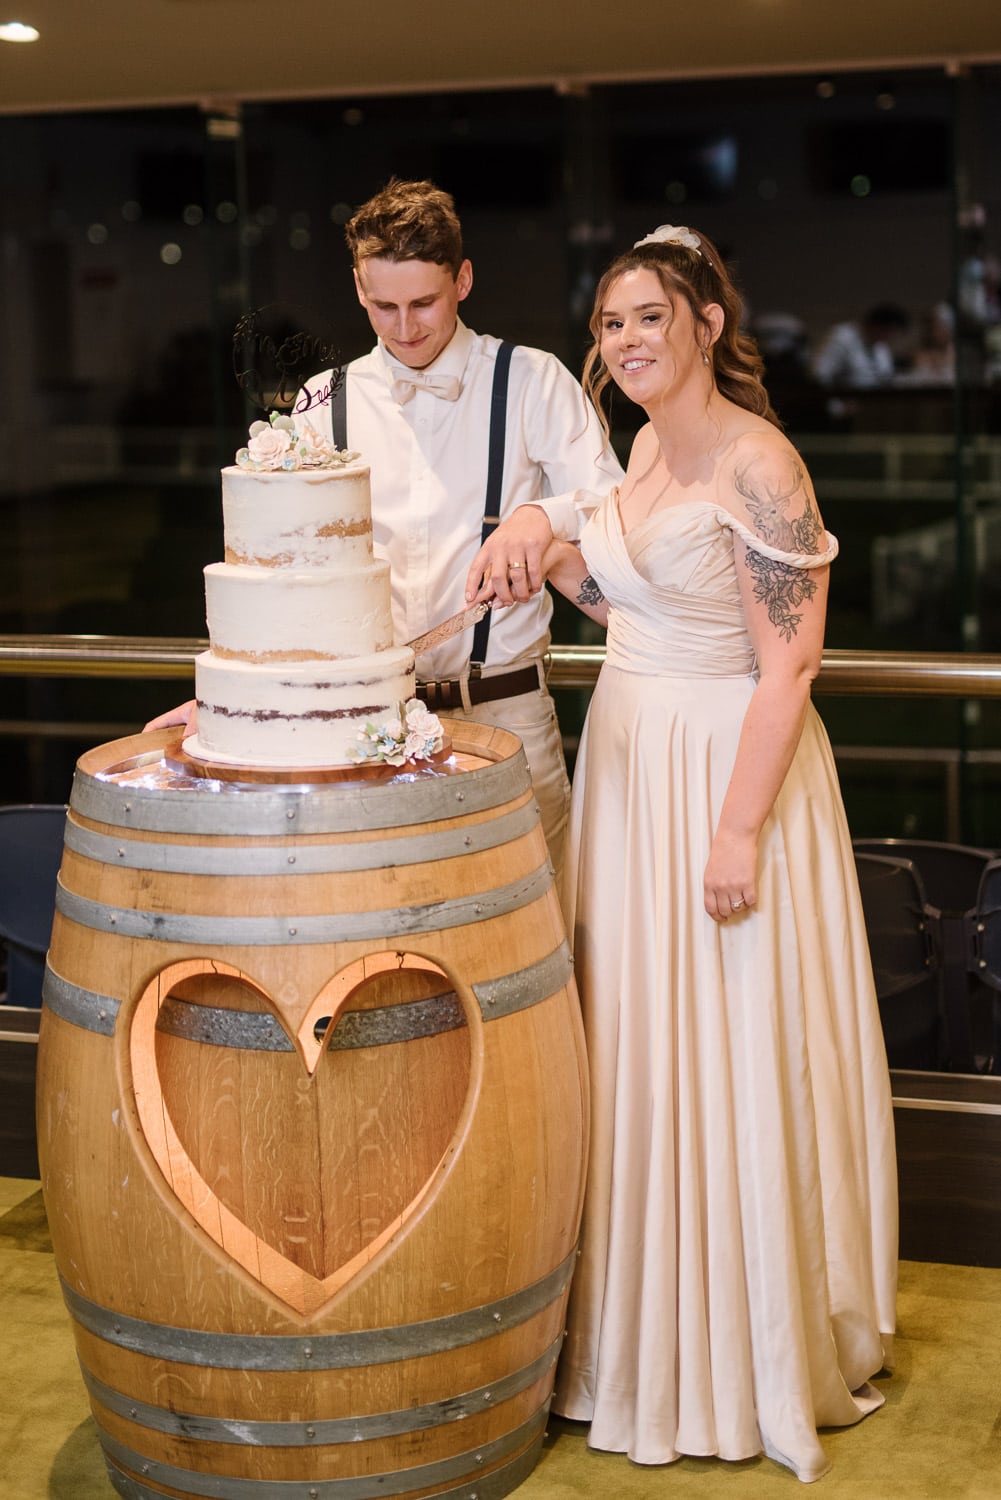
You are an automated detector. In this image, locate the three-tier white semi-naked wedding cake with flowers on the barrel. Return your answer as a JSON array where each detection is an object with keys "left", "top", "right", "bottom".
[{"left": 186, "top": 417, "right": 419, "bottom": 768}]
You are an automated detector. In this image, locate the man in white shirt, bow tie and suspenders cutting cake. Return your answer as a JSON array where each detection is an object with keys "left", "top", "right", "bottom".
[{"left": 294, "top": 180, "right": 621, "bottom": 873}]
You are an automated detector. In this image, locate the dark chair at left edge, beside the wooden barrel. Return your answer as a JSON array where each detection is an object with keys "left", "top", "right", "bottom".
[{"left": 0, "top": 803, "right": 66, "bottom": 1007}]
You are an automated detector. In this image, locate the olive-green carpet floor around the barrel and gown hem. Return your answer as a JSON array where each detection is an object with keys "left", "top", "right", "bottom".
[{"left": 0, "top": 1178, "right": 1001, "bottom": 1500}]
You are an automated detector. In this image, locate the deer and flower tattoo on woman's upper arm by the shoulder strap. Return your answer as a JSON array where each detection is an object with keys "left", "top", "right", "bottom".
[{"left": 734, "top": 459, "right": 824, "bottom": 641}]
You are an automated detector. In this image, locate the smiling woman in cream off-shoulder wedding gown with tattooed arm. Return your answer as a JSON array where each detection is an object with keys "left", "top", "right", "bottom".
[{"left": 473, "top": 227, "right": 896, "bottom": 1481}]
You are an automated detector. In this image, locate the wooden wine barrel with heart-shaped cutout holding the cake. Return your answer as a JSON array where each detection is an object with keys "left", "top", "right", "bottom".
[{"left": 38, "top": 722, "right": 587, "bottom": 1500}]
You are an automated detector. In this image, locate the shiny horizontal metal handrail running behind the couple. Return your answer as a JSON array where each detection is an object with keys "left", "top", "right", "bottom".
[{"left": 0, "top": 635, "right": 1001, "bottom": 698}]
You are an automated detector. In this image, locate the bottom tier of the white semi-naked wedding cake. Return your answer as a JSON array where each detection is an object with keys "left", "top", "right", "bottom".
[{"left": 195, "top": 647, "right": 414, "bottom": 767}]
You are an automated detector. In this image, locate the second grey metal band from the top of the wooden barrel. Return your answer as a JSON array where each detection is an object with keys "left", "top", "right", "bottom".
[{"left": 66, "top": 800, "right": 539, "bottom": 878}]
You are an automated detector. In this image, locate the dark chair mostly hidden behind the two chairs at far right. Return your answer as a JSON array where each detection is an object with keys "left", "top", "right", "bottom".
[{"left": 854, "top": 839, "right": 996, "bottom": 1073}]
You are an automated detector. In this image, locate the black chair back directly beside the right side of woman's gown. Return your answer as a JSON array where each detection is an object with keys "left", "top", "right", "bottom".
[{"left": 855, "top": 849, "right": 942, "bottom": 1071}]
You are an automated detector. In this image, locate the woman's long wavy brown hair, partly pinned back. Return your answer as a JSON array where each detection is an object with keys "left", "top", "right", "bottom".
[{"left": 581, "top": 231, "right": 782, "bottom": 437}]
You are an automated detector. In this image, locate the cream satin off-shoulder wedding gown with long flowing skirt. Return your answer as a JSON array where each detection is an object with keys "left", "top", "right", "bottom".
[{"left": 555, "top": 494, "right": 897, "bottom": 1479}]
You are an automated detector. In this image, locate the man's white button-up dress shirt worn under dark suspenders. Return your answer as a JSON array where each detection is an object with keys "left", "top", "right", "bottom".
[{"left": 296, "top": 323, "right": 621, "bottom": 678}]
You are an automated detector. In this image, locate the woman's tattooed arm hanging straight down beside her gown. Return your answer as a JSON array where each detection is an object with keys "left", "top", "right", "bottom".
[{"left": 704, "top": 434, "right": 830, "bottom": 921}]
